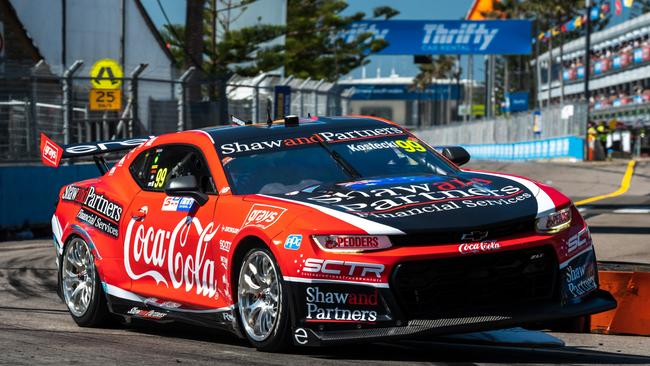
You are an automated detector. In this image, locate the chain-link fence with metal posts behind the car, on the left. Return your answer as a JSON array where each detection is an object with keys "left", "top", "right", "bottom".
[{"left": 0, "top": 61, "right": 349, "bottom": 162}]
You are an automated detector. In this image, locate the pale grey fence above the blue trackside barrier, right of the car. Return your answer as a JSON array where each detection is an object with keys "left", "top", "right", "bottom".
[{"left": 416, "top": 104, "right": 587, "bottom": 145}]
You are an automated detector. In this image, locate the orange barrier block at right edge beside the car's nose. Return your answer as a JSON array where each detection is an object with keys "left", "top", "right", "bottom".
[{"left": 591, "top": 270, "right": 650, "bottom": 335}]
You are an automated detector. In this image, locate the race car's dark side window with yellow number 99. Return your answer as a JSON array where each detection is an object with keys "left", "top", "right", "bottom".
[{"left": 130, "top": 145, "right": 216, "bottom": 193}]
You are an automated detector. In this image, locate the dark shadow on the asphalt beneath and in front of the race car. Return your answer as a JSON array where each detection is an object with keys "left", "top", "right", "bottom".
[{"left": 120, "top": 321, "right": 650, "bottom": 365}]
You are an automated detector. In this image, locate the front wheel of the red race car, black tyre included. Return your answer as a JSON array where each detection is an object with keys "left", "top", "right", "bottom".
[{"left": 237, "top": 248, "right": 290, "bottom": 352}]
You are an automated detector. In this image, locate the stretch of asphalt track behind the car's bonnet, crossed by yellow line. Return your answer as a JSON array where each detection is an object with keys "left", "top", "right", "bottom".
[{"left": 468, "top": 160, "right": 650, "bottom": 264}]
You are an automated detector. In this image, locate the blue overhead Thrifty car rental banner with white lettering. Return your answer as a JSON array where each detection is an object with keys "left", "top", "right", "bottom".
[{"left": 343, "top": 20, "right": 532, "bottom": 55}]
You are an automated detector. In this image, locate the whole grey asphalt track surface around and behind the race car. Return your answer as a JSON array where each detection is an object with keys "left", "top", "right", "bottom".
[{"left": 0, "top": 162, "right": 650, "bottom": 366}]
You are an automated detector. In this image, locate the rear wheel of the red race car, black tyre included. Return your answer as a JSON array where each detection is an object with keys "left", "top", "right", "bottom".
[{"left": 60, "top": 237, "right": 109, "bottom": 327}]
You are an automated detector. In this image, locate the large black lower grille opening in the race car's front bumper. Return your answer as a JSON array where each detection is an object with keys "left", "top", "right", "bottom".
[{"left": 391, "top": 246, "right": 558, "bottom": 319}]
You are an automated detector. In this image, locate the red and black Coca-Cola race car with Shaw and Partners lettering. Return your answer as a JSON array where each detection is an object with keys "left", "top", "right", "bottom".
[{"left": 41, "top": 116, "right": 616, "bottom": 351}]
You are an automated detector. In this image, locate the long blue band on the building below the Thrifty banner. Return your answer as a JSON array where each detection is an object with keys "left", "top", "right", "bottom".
[{"left": 350, "top": 84, "right": 461, "bottom": 100}]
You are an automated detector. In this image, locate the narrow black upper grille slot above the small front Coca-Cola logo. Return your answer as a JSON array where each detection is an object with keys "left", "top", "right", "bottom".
[{"left": 390, "top": 219, "right": 535, "bottom": 246}]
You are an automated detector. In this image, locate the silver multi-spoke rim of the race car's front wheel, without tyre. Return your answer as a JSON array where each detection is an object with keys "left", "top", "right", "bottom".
[{"left": 237, "top": 251, "right": 282, "bottom": 342}]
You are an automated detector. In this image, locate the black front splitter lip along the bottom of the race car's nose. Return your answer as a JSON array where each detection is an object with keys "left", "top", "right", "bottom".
[{"left": 293, "top": 290, "right": 616, "bottom": 346}]
